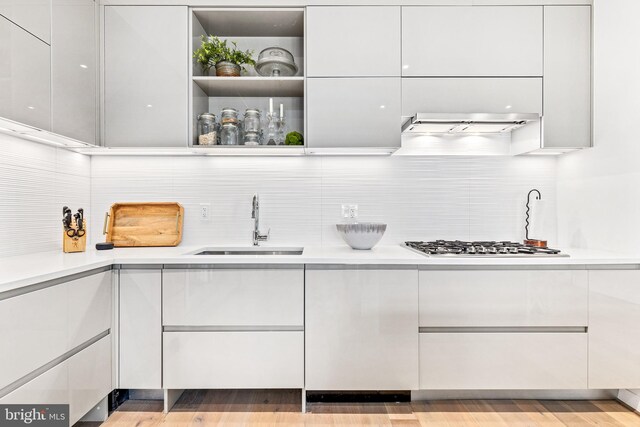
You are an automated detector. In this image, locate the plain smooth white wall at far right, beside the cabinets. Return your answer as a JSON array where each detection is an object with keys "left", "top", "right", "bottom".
[{"left": 558, "top": 0, "right": 640, "bottom": 253}]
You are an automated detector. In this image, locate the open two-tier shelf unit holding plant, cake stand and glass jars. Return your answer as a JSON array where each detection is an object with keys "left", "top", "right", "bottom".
[{"left": 190, "top": 8, "right": 305, "bottom": 149}]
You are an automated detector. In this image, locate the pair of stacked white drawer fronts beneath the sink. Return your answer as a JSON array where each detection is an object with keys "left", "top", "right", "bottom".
[{"left": 162, "top": 265, "right": 304, "bottom": 389}]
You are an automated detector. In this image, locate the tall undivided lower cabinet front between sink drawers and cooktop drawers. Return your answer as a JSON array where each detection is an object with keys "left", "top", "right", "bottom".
[{"left": 305, "top": 266, "right": 418, "bottom": 390}]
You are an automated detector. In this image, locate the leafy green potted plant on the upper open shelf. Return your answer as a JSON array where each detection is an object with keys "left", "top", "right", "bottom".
[{"left": 193, "top": 36, "right": 256, "bottom": 77}]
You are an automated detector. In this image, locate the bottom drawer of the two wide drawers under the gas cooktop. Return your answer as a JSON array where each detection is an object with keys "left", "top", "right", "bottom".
[{"left": 420, "top": 333, "right": 587, "bottom": 390}]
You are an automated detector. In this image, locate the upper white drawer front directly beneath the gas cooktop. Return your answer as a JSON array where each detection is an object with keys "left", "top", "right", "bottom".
[{"left": 420, "top": 270, "right": 588, "bottom": 327}]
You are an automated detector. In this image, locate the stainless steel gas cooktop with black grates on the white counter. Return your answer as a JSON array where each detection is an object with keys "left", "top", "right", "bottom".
[{"left": 404, "top": 240, "right": 569, "bottom": 258}]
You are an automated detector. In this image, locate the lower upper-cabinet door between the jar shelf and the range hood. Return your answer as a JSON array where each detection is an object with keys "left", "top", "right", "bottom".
[{"left": 307, "top": 77, "right": 401, "bottom": 150}]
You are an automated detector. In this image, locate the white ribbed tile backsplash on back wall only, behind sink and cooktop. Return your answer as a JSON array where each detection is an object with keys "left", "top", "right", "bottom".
[{"left": 91, "top": 156, "right": 556, "bottom": 245}]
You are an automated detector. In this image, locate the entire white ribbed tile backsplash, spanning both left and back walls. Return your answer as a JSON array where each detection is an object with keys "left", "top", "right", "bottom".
[{"left": 0, "top": 134, "right": 557, "bottom": 257}]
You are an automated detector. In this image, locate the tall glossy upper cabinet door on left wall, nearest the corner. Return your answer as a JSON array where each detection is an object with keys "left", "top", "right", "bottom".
[{"left": 51, "top": 0, "right": 98, "bottom": 144}]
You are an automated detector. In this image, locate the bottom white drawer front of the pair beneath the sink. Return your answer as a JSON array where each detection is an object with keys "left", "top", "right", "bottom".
[{"left": 163, "top": 331, "right": 304, "bottom": 388}]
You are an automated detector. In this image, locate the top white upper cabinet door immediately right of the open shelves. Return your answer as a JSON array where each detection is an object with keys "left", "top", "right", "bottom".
[{"left": 307, "top": 6, "right": 401, "bottom": 77}]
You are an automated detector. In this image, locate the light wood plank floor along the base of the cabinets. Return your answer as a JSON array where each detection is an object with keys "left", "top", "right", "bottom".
[{"left": 83, "top": 390, "right": 640, "bottom": 427}]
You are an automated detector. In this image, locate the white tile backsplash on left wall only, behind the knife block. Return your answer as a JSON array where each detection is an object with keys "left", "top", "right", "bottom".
[{"left": 0, "top": 133, "right": 91, "bottom": 257}]
